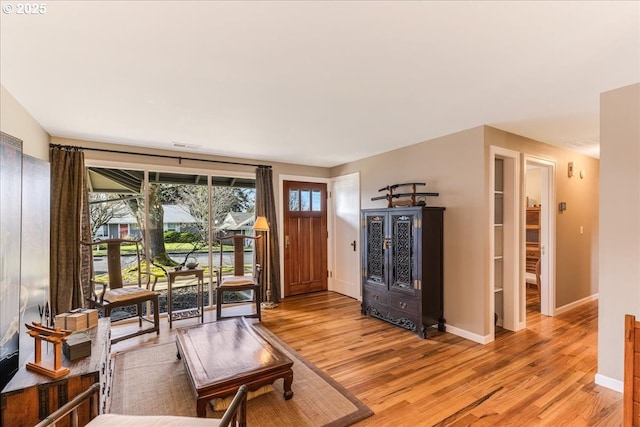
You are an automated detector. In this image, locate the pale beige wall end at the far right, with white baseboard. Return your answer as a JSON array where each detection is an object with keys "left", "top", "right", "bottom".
[{"left": 596, "top": 83, "right": 640, "bottom": 391}]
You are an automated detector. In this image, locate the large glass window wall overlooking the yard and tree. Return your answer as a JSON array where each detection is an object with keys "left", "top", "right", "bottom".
[{"left": 87, "top": 167, "right": 255, "bottom": 312}]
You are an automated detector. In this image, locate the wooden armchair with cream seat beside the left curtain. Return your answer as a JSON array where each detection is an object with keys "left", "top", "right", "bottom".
[{"left": 81, "top": 239, "right": 160, "bottom": 344}]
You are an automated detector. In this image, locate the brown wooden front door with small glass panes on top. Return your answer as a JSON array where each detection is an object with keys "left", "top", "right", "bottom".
[{"left": 283, "top": 181, "right": 327, "bottom": 297}]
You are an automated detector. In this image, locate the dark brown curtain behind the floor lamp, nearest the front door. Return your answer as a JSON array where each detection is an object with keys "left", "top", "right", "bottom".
[{"left": 255, "top": 167, "right": 281, "bottom": 302}]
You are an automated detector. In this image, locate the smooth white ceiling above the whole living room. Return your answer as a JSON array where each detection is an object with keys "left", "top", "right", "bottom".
[{"left": 0, "top": 1, "right": 640, "bottom": 166}]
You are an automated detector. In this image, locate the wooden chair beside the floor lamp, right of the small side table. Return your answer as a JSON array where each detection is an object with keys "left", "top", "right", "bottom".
[{"left": 216, "top": 234, "right": 262, "bottom": 320}]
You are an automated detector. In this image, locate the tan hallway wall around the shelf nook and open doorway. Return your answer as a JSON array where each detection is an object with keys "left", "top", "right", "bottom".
[{"left": 485, "top": 126, "right": 600, "bottom": 309}]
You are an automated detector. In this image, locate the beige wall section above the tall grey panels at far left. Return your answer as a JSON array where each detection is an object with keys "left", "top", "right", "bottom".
[{"left": 0, "top": 86, "right": 49, "bottom": 162}]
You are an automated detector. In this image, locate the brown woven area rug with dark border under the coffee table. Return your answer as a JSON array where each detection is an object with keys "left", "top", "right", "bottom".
[{"left": 108, "top": 324, "right": 373, "bottom": 427}]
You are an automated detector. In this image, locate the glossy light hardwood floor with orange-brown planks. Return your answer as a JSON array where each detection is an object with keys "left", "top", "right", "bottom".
[{"left": 113, "top": 290, "right": 622, "bottom": 426}]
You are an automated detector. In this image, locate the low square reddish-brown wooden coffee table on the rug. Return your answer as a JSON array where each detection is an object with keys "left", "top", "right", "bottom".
[{"left": 176, "top": 318, "right": 293, "bottom": 417}]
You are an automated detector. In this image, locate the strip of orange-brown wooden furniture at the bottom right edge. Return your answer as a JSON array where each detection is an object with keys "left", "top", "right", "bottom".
[{"left": 622, "top": 314, "right": 640, "bottom": 427}]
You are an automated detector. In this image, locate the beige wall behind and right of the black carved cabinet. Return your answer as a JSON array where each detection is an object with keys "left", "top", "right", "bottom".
[{"left": 331, "top": 127, "right": 490, "bottom": 341}]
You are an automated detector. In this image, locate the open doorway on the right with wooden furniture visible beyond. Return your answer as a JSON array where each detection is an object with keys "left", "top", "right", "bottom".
[{"left": 522, "top": 155, "right": 555, "bottom": 316}]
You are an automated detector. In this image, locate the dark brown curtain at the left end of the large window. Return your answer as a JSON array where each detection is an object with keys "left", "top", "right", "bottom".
[{"left": 49, "top": 147, "right": 88, "bottom": 314}]
